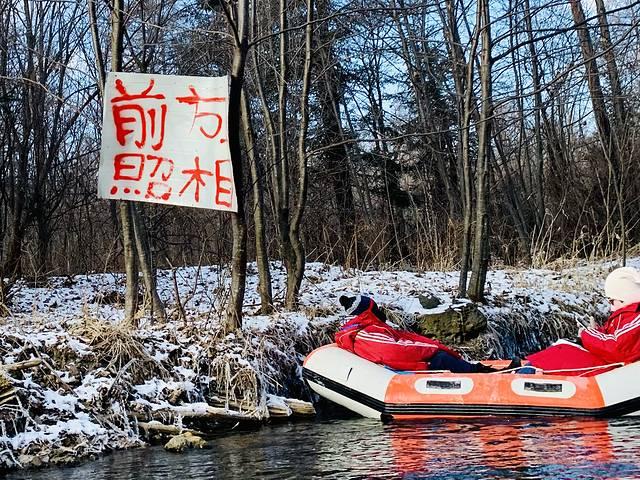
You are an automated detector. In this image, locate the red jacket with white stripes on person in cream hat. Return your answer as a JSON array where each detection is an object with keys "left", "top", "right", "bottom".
[{"left": 580, "top": 303, "right": 640, "bottom": 363}]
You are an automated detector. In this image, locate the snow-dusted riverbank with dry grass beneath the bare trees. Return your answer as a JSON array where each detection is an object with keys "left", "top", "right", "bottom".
[{"left": 0, "top": 258, "right": 640, "bottom": 469}]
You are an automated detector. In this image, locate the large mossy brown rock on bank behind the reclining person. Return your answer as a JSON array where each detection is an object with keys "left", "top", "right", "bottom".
[{"left": 416, "top": 303, "right": 487, "bottom": 344}]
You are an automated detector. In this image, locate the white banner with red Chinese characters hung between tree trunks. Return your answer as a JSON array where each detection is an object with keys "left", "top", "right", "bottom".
[{"left": 98, "top": 72, "right": 238, "bottom": 212}]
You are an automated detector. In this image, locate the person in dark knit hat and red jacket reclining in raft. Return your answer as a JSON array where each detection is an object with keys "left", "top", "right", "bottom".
[{"left": 335, "top": 295, "right": 496, "bottom": 373}]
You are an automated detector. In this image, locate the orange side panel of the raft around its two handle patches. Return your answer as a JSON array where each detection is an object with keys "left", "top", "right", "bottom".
[{"left": 384, "top": 373, "right": 604, "bottom": 408}]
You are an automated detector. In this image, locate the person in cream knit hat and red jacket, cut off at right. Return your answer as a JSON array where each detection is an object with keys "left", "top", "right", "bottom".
[{"left": 527, "top": 267, "right": 640, "bottom": 376}]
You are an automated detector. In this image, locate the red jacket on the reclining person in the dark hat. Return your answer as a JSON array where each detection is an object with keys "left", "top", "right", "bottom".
[{"left": 335, "top": 308, "right": 460, "bottom": 370}]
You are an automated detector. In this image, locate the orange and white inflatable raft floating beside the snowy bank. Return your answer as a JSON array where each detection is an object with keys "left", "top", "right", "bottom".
[{"left": 303, "top": 344, "right": 640, "bottom": 420}]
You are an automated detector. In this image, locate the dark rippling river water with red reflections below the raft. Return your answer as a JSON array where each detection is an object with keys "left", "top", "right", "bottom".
[{"left": 7, "top": 417, "right": 640, "bottom": 480}]
